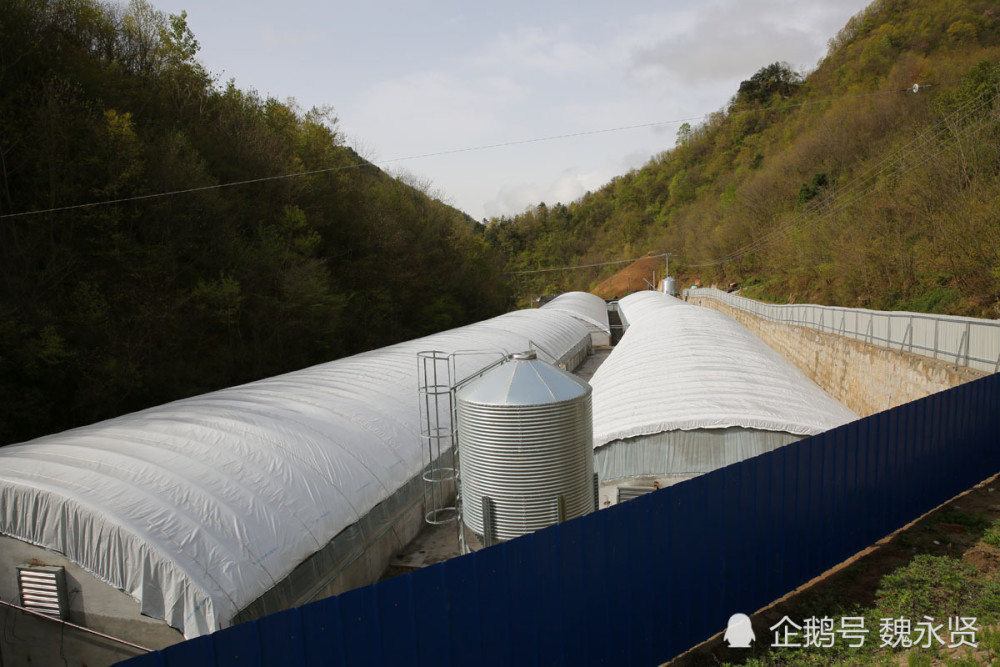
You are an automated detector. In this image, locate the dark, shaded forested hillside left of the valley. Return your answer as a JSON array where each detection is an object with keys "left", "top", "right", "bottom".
[{"left": 0, "top": 0, "right": 505, "bottom": 444}]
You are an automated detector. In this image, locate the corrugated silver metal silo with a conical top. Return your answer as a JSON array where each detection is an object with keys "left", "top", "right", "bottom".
[{"left": 456, "top": 353, "right": 596, "bottom": 544}]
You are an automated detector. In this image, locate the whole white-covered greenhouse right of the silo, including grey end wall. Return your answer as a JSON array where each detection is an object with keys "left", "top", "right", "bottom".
[{"left": 591, "top": 291, "right": 858, "bottom": 481}]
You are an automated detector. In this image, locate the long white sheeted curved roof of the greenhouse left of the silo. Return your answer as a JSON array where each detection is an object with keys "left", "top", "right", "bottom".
[{"left": 0, "top": 310, "right": 589, "bottom": 637}]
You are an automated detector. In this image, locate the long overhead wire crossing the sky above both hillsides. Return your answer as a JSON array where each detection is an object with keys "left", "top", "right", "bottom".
[{"left": 0, "top": 84, "right": 920, "bottom": 220}]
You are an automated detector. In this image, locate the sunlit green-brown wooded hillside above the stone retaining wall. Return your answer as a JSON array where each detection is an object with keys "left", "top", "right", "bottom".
[{"left": 487, "top": 0, "right": 1000, "bottom": 318}]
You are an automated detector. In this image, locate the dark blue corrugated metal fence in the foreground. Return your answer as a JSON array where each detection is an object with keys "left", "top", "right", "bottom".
[{"left": 122, "top": 375, "right": 1000, "bottom": 667}]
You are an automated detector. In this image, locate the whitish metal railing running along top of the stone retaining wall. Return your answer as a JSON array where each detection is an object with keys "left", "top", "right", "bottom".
[{"left": 684, "top": 287, "right": 1000, "bottom": 373}]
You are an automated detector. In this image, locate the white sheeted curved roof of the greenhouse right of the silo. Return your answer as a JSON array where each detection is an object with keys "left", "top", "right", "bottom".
[{"left": 591, "top": 291, "right": 857, "bottom": 447}]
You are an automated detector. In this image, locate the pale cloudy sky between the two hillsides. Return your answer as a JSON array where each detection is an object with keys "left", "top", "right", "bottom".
[{"left": 151, "top": 0, "right": 868, "bottom": 220}]
